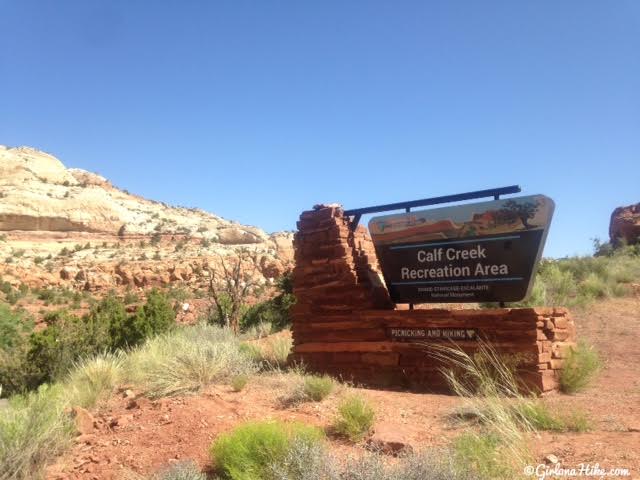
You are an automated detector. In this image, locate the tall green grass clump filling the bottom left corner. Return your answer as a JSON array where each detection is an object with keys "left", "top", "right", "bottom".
[{"left": 0, "top": 385, "right": 74, "bottom": 480}]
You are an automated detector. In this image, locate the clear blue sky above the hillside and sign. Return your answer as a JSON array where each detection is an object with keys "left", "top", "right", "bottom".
[{"left": 0, "top": 0, "right": 640, "bottom": 257}]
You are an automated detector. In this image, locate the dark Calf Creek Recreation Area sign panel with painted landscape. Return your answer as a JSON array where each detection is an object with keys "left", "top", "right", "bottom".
[{"left": 369, "top": 195, "right": 554, "bottom": 303}]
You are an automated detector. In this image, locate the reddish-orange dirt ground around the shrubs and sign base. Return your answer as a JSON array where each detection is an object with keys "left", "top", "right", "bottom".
[{"left": 47, "top": 298, "right": 640, "bottom": 480}]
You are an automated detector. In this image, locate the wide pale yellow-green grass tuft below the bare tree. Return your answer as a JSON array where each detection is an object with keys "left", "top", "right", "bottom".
[{"left": 126, "top": 324, "right": 255, "bottom": 397}]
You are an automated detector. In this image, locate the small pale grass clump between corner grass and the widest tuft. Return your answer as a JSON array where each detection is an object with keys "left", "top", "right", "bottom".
[{"left": 64, "top": 352, "right": 125, "bottom": 408}]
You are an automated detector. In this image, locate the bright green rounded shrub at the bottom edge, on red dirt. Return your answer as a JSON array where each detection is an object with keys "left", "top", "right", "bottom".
[{"left": 210, "top": 422, "right": 323, "bottom": 480}]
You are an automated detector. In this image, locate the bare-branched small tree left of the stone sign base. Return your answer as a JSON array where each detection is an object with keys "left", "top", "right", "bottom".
[{"left": 209, "top": 249, "right": 257, "bottom": 334}]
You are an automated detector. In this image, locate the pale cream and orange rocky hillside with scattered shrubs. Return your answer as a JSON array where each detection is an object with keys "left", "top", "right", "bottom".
[{"left": 0, "top": 146, "right": 292, "bottom": 291}]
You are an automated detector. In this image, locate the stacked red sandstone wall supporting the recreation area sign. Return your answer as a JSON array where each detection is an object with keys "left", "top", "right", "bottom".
[{"left": 291, "top": 205, "right": 575, "bottom": 392}]
